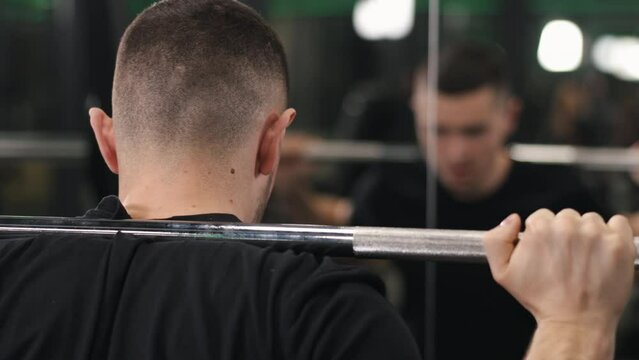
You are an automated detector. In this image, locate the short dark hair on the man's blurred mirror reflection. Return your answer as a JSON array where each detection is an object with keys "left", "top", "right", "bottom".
[{"left": 438, "top": 40, "right": 511, "bottom": 95}]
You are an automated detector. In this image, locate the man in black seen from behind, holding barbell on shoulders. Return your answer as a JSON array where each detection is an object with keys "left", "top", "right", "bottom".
[{"left": 0, "top": 0, "right": 634, "bottom": 359}]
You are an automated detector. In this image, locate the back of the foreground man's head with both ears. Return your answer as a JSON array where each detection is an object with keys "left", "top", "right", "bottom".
[{"left": 91, "top": 0, "right": 295, "bottom": 221}]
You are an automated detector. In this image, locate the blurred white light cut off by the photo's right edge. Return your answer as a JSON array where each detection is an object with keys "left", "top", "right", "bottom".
[{"left": 592, "top": 35, "right": 639, "bottom": 81}]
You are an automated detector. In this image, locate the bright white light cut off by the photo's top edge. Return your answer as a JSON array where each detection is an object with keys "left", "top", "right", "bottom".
[{"left": 353, "top": 0, "right": 415, "bottom": 40}]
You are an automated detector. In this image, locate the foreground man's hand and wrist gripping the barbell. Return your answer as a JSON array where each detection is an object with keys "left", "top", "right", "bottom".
[{"left": 484, "top": 209, "right": 637, "bottom": 358}]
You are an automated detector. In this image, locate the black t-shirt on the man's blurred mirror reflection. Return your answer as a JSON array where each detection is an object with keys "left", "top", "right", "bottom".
[{"left": 352, "top": 162, "right": 608, "bottom": 359}]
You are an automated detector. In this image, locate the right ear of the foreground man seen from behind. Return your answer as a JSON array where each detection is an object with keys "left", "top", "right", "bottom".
[{"left": 255, "top": 109, "right": 297, "bottom": 175}]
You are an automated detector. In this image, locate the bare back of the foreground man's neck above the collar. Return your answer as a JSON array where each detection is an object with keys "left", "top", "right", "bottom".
[{"left": 119, "top": 167, "right": 253, "bottom": 222}]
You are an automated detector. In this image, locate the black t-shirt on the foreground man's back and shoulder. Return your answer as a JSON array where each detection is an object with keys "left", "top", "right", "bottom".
[{"left": 0, "top": 197, "right": 419, "bottom": 360}]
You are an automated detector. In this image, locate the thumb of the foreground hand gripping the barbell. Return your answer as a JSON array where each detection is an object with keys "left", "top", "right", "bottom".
[{"left": 483, "top": 214, "right": 521, "bottom": 282}]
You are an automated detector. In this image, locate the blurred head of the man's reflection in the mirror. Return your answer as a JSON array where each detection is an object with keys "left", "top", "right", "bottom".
[{"left": 413, "top": 42, "right": 520, "bottom": 199}]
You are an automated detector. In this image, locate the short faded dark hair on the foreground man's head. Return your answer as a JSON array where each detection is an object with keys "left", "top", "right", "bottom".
[{"left": 113, "top": 0, "right": 288, "bottom": 158}]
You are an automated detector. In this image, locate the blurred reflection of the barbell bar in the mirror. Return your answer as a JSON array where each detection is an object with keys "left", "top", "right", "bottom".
[{"left": 0, "top": 133, "right": 639, "bottom": 171}]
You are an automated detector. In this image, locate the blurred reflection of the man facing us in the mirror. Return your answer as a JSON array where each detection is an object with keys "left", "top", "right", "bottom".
[{"left": 351, "top": 41, "right": 605, "bottom": 359}]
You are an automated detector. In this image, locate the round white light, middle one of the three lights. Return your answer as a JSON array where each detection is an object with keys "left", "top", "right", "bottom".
[{"left": 537, "top": 20, "right": 584, "bottom": 72}]
